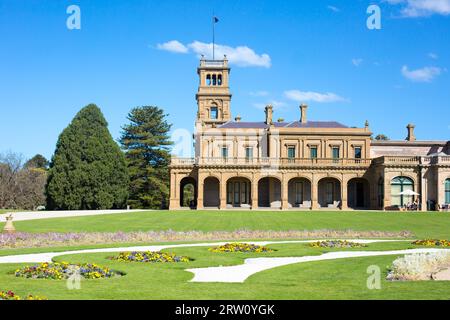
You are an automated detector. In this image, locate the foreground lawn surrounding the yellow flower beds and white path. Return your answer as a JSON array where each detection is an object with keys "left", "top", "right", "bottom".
[{"left": 0, "top": 242, "right": 450, "bottom": 299}]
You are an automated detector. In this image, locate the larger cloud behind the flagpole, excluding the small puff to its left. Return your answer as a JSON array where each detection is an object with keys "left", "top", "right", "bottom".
[{"left": 188, "top": 41, "right": 271, "bottom": 68}]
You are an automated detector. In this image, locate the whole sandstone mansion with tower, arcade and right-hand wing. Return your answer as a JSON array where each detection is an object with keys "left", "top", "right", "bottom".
[{"left": 169, "top": 57, "right": 450, "bottom": 210}]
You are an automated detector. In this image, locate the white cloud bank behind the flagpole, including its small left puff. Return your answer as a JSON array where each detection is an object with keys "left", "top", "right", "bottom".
[{"left": 157, "top": 40, "right": 271, "bottom": 68}]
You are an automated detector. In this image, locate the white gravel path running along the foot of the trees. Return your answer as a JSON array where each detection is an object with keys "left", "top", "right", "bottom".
[{"left": 0, "top": 210, "right": 147, "bottom": 222}]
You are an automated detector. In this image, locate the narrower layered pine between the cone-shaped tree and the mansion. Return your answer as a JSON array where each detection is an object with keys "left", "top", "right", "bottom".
[{"left": 120, "top": 106, "right": 173, "bottom": 209}]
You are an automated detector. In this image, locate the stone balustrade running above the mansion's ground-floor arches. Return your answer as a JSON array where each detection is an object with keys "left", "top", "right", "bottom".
[{"left": 171, "top": 157, "right": 372, "bottom": 167}]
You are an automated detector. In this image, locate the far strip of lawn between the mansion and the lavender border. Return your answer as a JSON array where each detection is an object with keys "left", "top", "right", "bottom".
[{"left": 0, "top": 211, "right": 450, "bottom": 238}]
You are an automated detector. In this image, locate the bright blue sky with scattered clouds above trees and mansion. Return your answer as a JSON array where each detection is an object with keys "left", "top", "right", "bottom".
[{"left": 0, "top": 0, "right": 450, "bottom": 158}]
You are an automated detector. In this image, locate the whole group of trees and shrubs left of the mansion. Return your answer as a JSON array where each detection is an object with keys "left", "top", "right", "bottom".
[{"left": 0, "top": 104, "right": 173, "bottom": 210}]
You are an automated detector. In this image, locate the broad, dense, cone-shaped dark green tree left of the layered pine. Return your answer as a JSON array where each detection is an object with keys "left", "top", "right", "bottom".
[{"left": 46, "top": 104, "right": 129, "bottom": 210}]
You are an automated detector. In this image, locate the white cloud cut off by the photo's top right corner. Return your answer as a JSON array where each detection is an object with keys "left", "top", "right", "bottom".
[{"left": 385, "top": 0, "right": 450, "bottom": 18}]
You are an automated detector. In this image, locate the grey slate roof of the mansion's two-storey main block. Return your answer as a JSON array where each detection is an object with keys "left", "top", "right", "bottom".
[{"left": 219, "top": 121, "right": 348, "bottom": 129}]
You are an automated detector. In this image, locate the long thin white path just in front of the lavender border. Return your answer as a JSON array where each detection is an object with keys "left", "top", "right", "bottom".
[{"left": 0, "top": 239, "right": 404, "bottom": 263}]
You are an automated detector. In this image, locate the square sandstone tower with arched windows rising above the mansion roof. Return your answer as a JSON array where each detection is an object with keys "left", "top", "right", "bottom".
[{"left": 196, "top": 56, "right": 231, "bottom": 126}]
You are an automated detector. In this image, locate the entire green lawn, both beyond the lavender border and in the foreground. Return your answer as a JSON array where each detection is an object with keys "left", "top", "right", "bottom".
[{"left": 0, "top": 211, "right": 450, "bottom": 299}]
